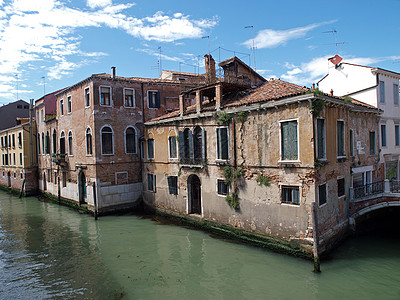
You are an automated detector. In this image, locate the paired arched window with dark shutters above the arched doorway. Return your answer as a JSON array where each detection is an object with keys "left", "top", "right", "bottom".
[{"left": 179, "top": 126, "right": 206, "bottom": 165}]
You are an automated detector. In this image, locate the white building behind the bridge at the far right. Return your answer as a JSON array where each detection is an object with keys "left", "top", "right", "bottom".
[{"left": 318, "top": 56, "right": 400, "bottom": 179}]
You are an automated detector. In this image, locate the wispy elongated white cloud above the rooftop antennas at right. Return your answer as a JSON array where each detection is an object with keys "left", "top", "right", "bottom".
[{"left": 242, "top": 21, "right": 336, "bottom": 49}]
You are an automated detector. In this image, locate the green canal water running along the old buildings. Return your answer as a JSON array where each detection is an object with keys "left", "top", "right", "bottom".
[{"left": 0, "top": 192, "right": 400, "bottom": 299}]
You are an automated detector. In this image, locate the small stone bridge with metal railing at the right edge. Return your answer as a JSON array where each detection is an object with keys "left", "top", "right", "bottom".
[{"left": 349, "top": 179, "right": 400, "bottom": 227}]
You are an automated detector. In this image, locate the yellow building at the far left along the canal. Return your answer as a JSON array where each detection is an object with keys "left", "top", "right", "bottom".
[{"left": 0, "top": 119, "right": 38, "bottom": 195}]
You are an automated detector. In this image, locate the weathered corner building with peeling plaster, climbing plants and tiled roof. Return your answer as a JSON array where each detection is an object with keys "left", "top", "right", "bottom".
[{"left": 143, "top": 59, "right": 378, "bottom": 252}]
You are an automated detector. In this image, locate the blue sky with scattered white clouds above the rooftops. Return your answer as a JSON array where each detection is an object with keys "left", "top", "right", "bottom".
[{"left": 0, "top": 0, "right": 400, "bottom": 105}]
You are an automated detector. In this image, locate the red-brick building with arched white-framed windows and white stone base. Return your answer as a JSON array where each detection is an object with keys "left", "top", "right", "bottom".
[{"left": 37, "top": 68, "right": 202, "bottom": 213}]
